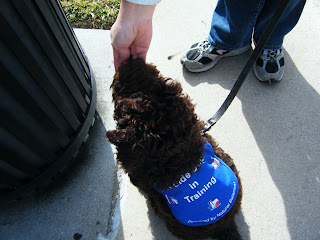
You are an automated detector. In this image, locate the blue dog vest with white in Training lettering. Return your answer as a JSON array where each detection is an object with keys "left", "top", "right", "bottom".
[{"left": 159, "top": 142, "right": 239, "bottom": 227}]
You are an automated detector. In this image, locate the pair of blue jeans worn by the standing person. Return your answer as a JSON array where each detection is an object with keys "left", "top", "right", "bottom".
[{"left": 208, "top": 0, "right": 306, "bottom": 50}]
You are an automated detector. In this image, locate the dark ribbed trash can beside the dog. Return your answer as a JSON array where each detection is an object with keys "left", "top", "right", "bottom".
[{"left": 0, "top": 0, "right": 96, "bottom": 201}]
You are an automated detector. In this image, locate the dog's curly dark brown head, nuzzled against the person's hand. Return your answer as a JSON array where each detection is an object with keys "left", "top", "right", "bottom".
[{"left": 107, "top": 59, "right": 197, "bottom": 145}]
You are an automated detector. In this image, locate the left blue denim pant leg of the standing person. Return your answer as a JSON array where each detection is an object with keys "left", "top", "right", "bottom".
[{"left": 208, "top": 0, "right": 264, "bottom": 50}]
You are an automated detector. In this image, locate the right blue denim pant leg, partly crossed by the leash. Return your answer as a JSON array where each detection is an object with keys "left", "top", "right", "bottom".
[{"left": 253, "top": 0, "right": 306, "bottom": 50}]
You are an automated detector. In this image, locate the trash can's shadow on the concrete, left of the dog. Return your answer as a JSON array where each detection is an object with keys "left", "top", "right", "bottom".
[{"left": 0, "top": 113, "right": 115, "bottom": 240}]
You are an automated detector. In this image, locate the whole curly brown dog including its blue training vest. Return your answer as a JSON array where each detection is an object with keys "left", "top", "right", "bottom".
[{"left": 106, "top": 59, "right": 242, "bottom": 240}]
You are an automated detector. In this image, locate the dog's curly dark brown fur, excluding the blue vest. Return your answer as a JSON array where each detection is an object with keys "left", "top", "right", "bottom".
[{"left": 107, "top": 59, "right": 242, "bottom": 239}]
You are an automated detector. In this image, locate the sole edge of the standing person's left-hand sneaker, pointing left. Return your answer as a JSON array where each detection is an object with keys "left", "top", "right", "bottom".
[{"left": 183, "top": 45, "right": 251, "bottom": 73}]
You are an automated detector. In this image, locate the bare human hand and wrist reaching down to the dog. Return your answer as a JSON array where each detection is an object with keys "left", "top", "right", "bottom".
[{"left": 110, "top": 0, "right": 155, "bottom": 70}]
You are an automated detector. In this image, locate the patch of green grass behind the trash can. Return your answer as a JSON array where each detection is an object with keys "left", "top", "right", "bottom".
[{"left": 60, "top": 0, "right": 120, "bottom": 29}]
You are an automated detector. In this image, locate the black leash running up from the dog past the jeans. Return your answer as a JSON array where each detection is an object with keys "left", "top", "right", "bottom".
[{"left": 202, "top": 0, "right": 290, "bottom": 133}]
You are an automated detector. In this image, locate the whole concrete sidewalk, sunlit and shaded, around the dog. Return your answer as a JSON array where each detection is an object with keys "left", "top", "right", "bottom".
[{"left": 0, "top": 0, "right": 320, "bottom": 240}]
